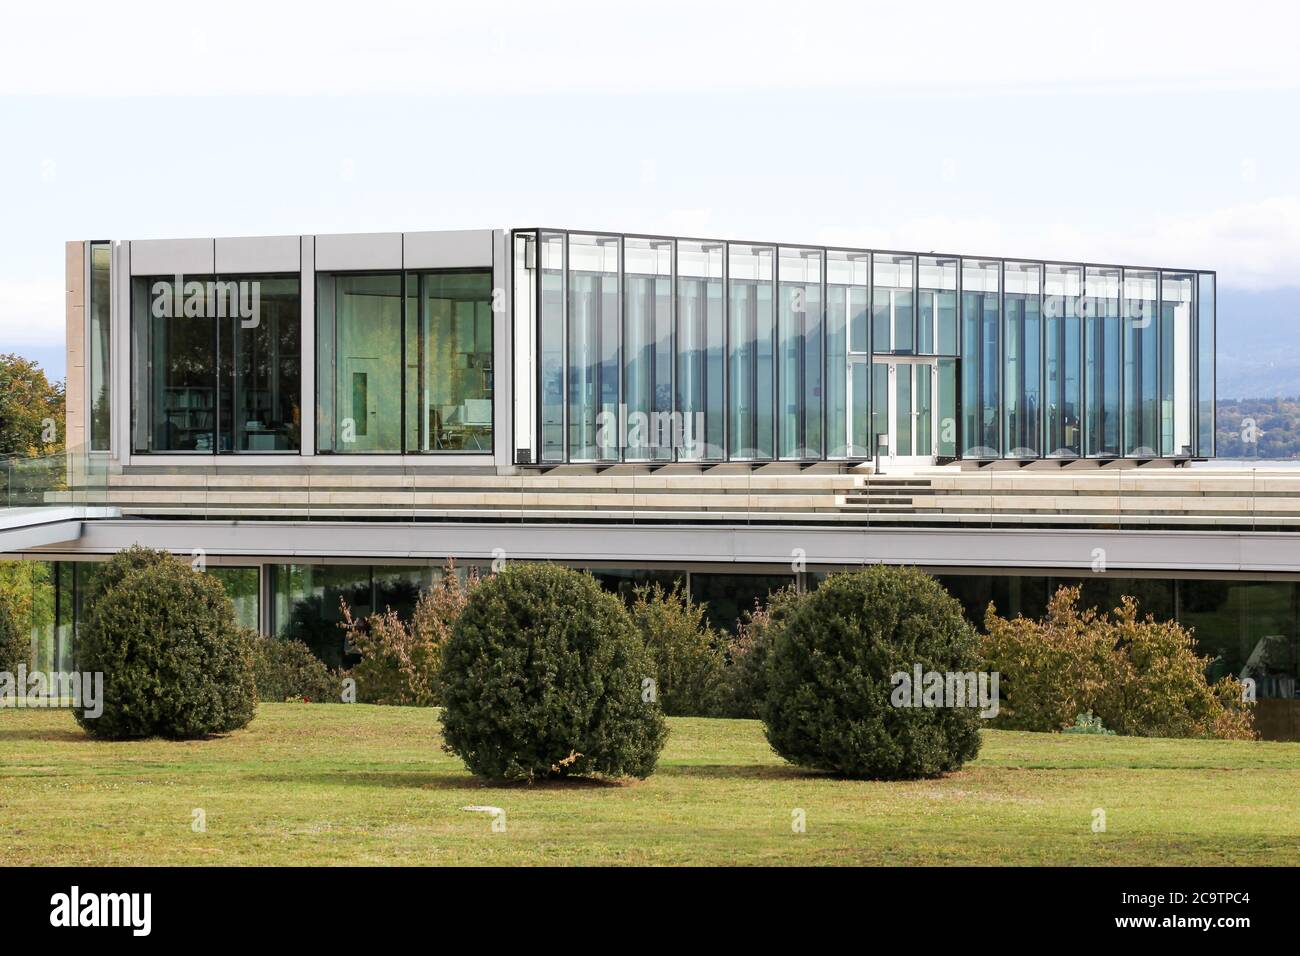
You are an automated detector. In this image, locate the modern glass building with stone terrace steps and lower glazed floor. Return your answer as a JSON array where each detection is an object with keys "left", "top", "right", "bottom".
[{"left": 15, "top": 228, "right": 1300, "bottom": 737}]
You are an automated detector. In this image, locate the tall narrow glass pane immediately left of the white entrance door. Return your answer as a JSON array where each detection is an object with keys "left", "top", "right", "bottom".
[{"left": 826, "top": 250, "right": 872, "bottom": 459}]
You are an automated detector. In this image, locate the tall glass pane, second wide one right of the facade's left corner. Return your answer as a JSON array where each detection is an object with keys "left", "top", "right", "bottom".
[{"left": 623, "top": 238, "right": 684, "bottom": 462}]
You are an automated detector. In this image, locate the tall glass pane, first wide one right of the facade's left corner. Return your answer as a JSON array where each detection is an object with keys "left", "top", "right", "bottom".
[{"left": 568, "top": 235, "right": 621, "bottom": 462}]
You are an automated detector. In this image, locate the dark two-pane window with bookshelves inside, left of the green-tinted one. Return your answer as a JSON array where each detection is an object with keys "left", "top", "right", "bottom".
[{"left": 131, "top": 276, "right": 302, "bottom": 454}]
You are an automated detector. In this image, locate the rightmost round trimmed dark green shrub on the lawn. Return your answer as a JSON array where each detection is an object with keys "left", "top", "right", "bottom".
[{"left": 762, "top": 564, "right": 980, "bottom": 779}]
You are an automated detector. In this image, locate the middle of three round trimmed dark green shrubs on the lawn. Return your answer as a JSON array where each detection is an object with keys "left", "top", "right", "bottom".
[{"left": 439, "top": 564, "right": 667, "bottom": 780}]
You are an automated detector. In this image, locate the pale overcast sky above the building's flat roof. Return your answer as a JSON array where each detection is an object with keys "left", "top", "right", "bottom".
[{"left": 0, "top": 0, "right": 1300, "bottom": 376}]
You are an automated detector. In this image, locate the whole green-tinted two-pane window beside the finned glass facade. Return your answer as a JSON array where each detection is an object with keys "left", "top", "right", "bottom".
[{"left": 316, "top": 271, "right": 494, "bottom": 454}]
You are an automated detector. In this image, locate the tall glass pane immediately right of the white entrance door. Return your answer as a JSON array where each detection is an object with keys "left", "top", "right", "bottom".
[{"left": 961, "top": 259, "right": 1002, "bottom": 458}]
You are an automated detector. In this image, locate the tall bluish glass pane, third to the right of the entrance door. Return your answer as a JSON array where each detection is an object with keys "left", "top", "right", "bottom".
[{"left": 1043, "top": 263, "right": 1083, "bottom": 458}]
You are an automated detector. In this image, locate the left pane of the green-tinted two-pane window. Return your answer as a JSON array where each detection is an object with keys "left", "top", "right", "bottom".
[{"left": 316, "top": 272, "right": 402, "bottom": 454}]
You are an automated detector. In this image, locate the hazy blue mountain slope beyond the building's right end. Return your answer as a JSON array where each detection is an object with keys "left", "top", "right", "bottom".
[{"left": 1217, "top": 286, "right": 1300, "bottom": 399}]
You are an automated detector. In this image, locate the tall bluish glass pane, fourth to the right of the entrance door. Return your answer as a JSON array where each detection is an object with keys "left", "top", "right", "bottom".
[{"left": 1082, "top": 267, "right": 1119, "bottom": 458}]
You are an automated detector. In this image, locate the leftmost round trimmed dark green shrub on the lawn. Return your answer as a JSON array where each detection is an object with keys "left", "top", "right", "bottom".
[{"left": 73, "top": 549, "right": 256, "bottom": 740}]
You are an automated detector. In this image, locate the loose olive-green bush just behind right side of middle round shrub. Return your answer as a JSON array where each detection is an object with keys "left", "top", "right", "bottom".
[{"left": 632, "top": 584, "right": 725, "bottom": 717}]
